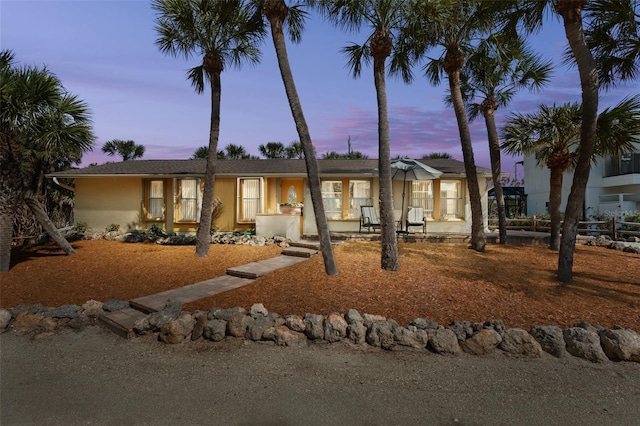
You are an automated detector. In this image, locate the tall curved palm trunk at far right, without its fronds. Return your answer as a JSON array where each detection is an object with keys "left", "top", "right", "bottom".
[{"left": 558, "top": 0, "right": 599, "bottom": 283}]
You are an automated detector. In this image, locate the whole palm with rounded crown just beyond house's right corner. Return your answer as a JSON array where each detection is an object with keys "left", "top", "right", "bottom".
[{"left": 462, "top": 37, "right": 552, "bottom": 244}]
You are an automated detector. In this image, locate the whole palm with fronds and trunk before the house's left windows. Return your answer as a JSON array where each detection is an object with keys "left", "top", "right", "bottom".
[{"left": 152, "top": 0, "right": 264, "bottom": 257}]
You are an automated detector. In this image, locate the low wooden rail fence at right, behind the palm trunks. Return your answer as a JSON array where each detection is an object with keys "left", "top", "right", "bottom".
[{"left": 489, "top": 216, "right": 640, "bottom": 240}]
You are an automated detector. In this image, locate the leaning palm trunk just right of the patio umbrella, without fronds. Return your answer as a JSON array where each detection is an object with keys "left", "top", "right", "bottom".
[{"left": 447, "top": 70, "right": 486, "bottom": 252}]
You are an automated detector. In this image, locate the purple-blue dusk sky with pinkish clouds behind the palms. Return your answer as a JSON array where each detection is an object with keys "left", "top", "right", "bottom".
[{"left": 0, "top": 0, "right": 638, "bottom": 177}]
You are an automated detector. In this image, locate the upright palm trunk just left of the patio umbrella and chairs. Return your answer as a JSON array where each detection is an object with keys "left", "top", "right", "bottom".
[{"left": 373, "top": 56, "right": 400, "bottom": 271}]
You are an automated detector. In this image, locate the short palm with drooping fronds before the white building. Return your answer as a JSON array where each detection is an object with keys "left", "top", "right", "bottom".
[{"left": 502, "top": 95, "right": 640, "bottom": 250}]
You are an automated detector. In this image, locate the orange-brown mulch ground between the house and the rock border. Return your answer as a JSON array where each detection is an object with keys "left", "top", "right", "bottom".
[{"left": 0, "top": 241, "right": 640, "bottom": 331}]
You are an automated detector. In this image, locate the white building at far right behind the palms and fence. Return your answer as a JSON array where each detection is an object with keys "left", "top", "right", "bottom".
[{"left": 524, "top": 143, "right": 640, "bottom": 219}]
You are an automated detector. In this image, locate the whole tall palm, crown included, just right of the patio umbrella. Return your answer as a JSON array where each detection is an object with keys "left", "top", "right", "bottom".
[{"left": 399, "top": 0, "right": 500, "bottom": 252}]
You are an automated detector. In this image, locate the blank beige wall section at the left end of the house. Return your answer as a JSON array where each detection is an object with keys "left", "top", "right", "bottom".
[{"left": 74, "top": 177, "right": 143, "bottom": 231}]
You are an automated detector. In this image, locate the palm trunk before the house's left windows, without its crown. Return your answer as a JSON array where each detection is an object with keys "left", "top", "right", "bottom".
[{"left": 196, "top": 68, "right": 222, "bottom": 257}]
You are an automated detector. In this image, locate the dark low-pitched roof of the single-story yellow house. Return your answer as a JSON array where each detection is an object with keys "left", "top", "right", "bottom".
[{"left": 47, "top": 159, "right": 491, "bottom": 178}]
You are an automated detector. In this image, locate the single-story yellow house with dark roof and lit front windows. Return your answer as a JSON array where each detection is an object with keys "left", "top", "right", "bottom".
[{"left": 48, "top": 159, "right": 491, "bottom": 240}]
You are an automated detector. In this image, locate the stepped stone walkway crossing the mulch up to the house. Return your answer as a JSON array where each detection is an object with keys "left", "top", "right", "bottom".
[{"left": 99, "top": 242, "right": 318, "bottom": 339}]
